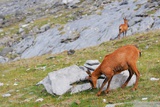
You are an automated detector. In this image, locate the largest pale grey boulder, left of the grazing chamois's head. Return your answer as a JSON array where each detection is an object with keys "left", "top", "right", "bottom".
[{"left": 38, "top": 65, "right": 87, "bottom": 95}]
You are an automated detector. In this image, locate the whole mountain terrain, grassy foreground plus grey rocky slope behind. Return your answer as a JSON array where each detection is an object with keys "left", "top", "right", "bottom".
[{"left": 0, "top": 0, "right": 160, "bottom": 107}]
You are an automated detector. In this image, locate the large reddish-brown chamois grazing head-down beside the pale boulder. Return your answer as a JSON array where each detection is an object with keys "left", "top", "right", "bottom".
[{"left": 87, "top": 45, "right": 141, "bottom": 96}]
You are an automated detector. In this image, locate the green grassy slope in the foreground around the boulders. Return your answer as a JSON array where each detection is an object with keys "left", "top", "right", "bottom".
[{"left": 0, "top": 30, "right": 160, "bottom": 107}]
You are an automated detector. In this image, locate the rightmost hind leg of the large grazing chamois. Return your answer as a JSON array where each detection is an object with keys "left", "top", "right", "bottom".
[{"left": 130, "top": 63, "right": 140, "bottom": 91}]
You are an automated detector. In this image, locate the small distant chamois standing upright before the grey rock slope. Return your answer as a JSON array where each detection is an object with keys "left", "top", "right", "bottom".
[{"left": 118, "top": 18, "right": 128, "bottom": 39}]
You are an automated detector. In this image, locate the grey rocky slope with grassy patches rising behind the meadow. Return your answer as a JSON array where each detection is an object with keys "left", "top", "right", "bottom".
[{"left": 0, "top": 0, "right": 160, "bottom": 63}]
